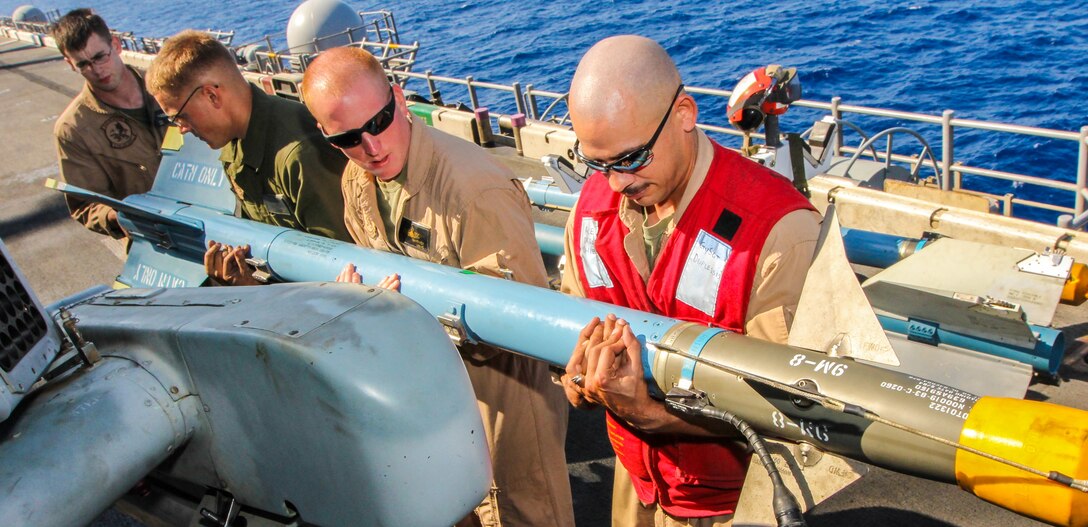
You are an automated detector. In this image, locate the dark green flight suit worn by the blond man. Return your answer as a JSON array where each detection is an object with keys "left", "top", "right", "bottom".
[{"left": 219, "top": 86, "right": 351, "bottom": 242}]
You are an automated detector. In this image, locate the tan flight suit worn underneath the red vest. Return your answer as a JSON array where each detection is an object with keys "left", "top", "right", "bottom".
[{"left": 561, "top": 131, "right": 820, "bottom": 527}]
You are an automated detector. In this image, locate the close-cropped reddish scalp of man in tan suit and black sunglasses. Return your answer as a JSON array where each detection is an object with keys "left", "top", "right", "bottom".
[{"left": 300, "top": 47, "right": 390, "bottom": 111}]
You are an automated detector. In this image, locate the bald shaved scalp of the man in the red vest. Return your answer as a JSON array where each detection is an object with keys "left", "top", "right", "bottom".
[{"left": 568, "top": 35, "right": 680, "bottom": 128}]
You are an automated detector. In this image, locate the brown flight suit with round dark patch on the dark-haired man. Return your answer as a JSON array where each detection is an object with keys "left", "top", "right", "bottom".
[{"left": 53, "top": 68, "right": 166, "bottom": 238}]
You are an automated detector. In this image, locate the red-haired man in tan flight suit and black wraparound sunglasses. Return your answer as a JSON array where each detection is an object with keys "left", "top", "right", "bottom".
[{"left": 302, "top": 48, "right": 574, "bottom": 526}]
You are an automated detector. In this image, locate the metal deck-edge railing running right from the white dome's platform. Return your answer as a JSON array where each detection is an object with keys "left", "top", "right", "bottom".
[{"left": 390, "top": 71, "right": 1088, "bottom": 229}]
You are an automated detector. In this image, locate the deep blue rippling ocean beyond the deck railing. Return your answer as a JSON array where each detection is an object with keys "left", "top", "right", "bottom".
[{"left": 8, "top": 0, "right": 1088, "bottom": 221}]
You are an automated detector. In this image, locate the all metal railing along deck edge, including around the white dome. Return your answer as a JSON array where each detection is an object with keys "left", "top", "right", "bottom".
[{"left": 0, "top": 11, "right": 1088, "bottom": 229}]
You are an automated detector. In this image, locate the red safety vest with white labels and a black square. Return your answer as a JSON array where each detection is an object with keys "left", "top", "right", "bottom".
[{"left": 573, "top": 142, "right": 815, "bottom": 517}]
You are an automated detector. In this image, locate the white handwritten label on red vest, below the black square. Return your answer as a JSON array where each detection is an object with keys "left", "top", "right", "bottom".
[{"left": 677, "top": 230, "right": 733, "bottom": 317}]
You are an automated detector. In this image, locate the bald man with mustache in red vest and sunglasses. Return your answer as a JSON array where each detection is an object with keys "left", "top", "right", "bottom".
[{"left": 562, "top": 36, "right": 819, "bottom": 527}]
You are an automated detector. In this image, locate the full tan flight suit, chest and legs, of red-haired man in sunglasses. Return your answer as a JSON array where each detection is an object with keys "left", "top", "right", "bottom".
[{"left": 344, "top": 123, "right": 574, "bottom": 526}]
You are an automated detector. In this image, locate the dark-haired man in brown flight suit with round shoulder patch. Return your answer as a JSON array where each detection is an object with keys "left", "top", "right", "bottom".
[{"left": 52, "top": 9, "right": 166, "bottom": 238}]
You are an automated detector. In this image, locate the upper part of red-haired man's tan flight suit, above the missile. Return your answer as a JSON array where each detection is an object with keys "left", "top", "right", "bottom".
[{"left": 343, "top": 123, "right": 547, "bottom": 286}]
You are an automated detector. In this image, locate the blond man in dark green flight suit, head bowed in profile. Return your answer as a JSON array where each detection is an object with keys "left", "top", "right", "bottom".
[{"left": 147, "top": 30, "right": 351, "bottom": 284}]
